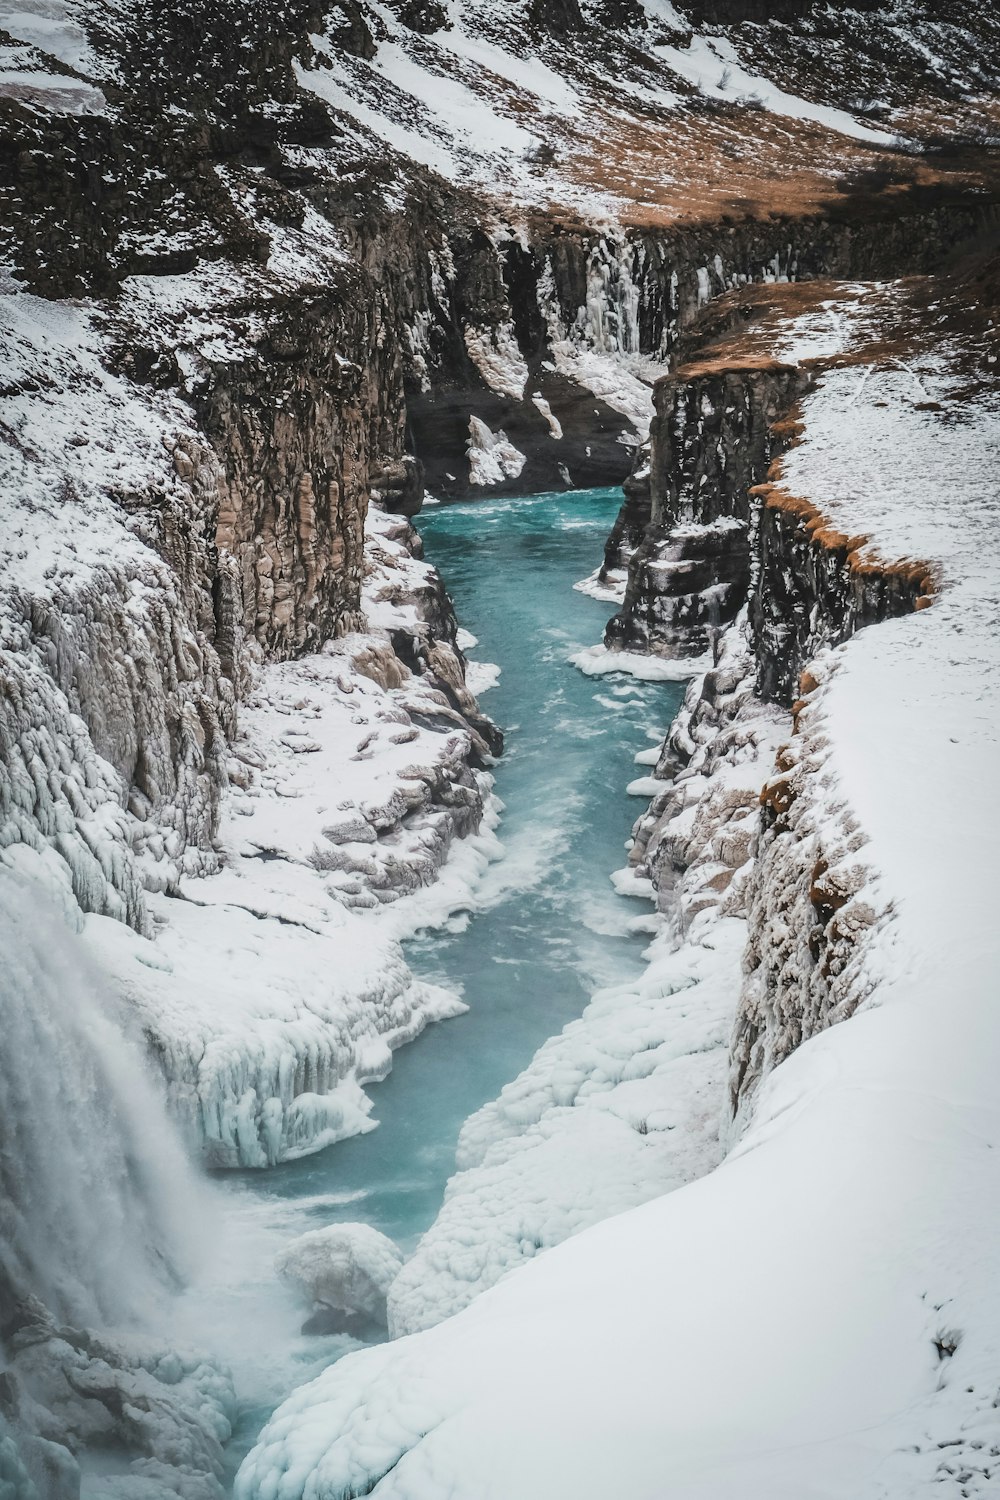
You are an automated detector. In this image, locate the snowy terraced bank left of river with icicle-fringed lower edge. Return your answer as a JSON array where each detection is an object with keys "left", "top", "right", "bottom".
[{"left": 88, "top": 510, "right": 496, "bottom": 1166}]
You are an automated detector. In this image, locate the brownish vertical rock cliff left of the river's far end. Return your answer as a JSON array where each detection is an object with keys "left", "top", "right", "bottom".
[{"left": 196, "top": 279, "right": 395, "bottom": 657}]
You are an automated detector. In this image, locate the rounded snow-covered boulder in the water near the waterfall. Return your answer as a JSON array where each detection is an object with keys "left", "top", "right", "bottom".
[{"left": 274, "top": 1224, "right": 403, "bottom": 1328}]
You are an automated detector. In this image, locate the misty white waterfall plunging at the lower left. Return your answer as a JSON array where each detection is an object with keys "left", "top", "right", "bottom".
[{"left": 0, "top": 870, "right": 207, "bottom": 1326}]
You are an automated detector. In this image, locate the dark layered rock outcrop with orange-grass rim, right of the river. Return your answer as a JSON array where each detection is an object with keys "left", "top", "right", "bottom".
[{"left": 604, "top": 337, "right": 934, "bottom": 693}]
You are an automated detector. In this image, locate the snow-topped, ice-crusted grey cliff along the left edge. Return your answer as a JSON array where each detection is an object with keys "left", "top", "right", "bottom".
[{"left": 0, "top": 282, "right": 234, "bottom": 929}]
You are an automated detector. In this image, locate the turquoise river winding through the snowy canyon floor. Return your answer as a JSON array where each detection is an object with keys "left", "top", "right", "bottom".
[{"left": 187, "top": 491, "right": 684, "bottom": 1469}]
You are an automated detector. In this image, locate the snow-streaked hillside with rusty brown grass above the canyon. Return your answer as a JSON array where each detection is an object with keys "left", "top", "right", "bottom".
[{"left": 298, "top": 0, "right": 996, "bottom": 224}]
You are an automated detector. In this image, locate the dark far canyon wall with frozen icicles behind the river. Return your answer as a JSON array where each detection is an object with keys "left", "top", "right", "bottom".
[{"left": 403, "top": 201, "right": 990, "bottom": 501}]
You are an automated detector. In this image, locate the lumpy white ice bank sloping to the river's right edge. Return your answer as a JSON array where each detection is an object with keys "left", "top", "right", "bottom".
[{"left": 390, "top": 921, "right": 731, "bottom": 1337}]
